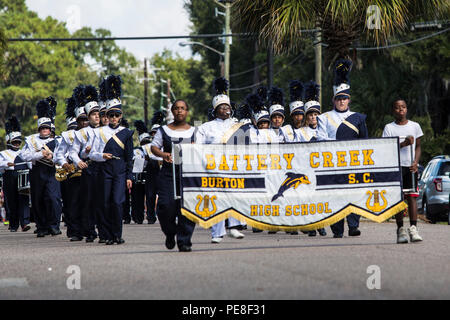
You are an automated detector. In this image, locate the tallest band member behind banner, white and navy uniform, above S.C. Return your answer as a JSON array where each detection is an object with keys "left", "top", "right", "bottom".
[{"left": 317, "top": 59, "right": 368, "bottom": 238}]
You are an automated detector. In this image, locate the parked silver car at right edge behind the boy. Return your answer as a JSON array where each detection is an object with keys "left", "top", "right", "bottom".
[{"left": 417, "top": 155, "right": 450, "bottom": 224}]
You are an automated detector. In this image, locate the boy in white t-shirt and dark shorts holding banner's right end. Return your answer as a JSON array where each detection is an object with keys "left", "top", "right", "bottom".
[{"left": 383, "top": 99, "right": 423, "bottom": 243}]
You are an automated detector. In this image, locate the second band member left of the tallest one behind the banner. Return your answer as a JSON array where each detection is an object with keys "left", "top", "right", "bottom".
[{"left": 281, "top": 80, "right": 305, "bottom": 142}]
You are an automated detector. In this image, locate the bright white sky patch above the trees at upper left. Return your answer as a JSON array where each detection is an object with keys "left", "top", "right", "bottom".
[{"left": 26, "top": 0, "right": 195, "bottom": 61}]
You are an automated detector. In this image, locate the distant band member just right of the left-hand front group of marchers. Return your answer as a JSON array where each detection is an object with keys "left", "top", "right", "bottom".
[{"left": 131, "top": 120, "right": 151, "bottom": 224}]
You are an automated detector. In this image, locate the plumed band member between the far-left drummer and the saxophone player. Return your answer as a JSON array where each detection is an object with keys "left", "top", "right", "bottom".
[{"left": 22, "top": 96, "right": 61, "bottom": 237}]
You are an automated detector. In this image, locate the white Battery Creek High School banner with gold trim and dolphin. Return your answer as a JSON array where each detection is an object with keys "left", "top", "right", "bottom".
[{"left": 180, "top": 138, "right": 407, "bottom": 231}]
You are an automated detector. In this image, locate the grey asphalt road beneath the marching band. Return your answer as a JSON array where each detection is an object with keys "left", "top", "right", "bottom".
[{"left": 0, "top": 220, "right": 450, "bottom": 300}]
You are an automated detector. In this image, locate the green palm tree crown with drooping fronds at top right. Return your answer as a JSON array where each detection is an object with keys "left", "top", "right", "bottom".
[{"left": 233, "top": 0, "right": 450, "bottom": 63}]
